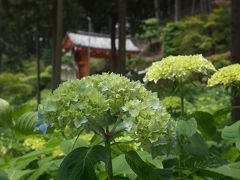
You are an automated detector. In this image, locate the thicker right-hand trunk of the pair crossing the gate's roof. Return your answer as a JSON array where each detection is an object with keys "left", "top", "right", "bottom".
[{"left": 118, "top": 0, "right": 127, "bottom": 74}]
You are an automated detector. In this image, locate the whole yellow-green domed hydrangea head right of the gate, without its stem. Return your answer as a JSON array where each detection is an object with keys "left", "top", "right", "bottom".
[{"left": 144, "top": 55, "right": 215, "bottom": 82}]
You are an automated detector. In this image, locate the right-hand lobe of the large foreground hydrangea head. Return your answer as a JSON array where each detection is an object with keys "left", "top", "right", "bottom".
[{"left": 123, "top": 97, "right": 175, "bottom": 145}]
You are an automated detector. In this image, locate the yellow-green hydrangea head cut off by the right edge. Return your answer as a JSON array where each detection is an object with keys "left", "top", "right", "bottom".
[{"left": 208, "top": 64, "right": 240, "bottom": 87}]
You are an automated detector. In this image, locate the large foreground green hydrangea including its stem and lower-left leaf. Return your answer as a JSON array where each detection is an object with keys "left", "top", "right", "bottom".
[{"left": 36, "top": 73, "right": 175, "bottom": 180}]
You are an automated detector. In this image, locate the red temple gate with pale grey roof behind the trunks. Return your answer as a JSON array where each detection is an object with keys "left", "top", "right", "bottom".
[{"left": 63, "top": 32, "right": 139, "bottom": 78}]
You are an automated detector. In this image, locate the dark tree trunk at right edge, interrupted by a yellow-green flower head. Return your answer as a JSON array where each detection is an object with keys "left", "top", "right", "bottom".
[{"left": 231, "top": 0, "right": 240, "bottom": 122}]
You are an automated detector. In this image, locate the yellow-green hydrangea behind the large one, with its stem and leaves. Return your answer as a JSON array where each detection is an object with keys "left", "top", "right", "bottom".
[{"left": 144, "top": 55, "right": 216, "bottom": 162}]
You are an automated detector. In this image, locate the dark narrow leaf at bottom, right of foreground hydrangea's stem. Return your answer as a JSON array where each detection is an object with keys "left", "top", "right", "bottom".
[{"left": 125, "top": 151, "right": 172, "bottom": 180}]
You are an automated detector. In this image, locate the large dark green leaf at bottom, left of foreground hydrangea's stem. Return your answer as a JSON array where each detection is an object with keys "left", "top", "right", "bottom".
[{"left": 57, "top": 145, "right": 108, "bottom": 180}]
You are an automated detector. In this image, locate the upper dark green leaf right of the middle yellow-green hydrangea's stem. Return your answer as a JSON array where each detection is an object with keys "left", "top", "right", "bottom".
[{"left": 193, "top": 111, "right": 216, "bottom": 138}]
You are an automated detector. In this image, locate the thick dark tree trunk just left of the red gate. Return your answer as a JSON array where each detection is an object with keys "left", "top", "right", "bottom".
[{"left": 52, "top": 0, "right": 63, "bottom": 90}]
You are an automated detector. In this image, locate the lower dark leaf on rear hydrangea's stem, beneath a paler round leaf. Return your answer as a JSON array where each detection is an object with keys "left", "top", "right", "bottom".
[{"left": 182, "top": 133, "right": 208, "bottom": 157}]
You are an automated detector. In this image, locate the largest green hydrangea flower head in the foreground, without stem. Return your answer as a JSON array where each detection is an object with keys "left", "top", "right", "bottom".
[{"left": 39, "top": 73, "right": 175, "bottom": 146}]
